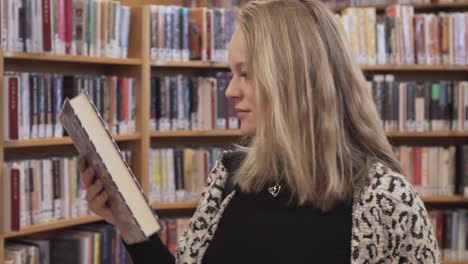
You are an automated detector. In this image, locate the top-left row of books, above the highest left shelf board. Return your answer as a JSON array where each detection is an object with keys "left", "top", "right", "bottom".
[{"left": 0, "top": 0, "right": 131, "bottom": 58}]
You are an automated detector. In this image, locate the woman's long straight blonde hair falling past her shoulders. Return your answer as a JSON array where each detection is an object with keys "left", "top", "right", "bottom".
[{"left": 235, "top": 0, "right": 401, "bottom": 211}]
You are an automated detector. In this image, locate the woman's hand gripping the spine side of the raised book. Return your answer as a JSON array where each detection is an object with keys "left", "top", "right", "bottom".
[{"left": 78, "top": 157, "right": 115, "bottom": 224}]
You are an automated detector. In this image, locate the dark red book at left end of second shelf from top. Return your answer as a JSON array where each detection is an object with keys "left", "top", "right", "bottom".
[{"left": 8, "top": 76, "right": 19, "bottom": 140}]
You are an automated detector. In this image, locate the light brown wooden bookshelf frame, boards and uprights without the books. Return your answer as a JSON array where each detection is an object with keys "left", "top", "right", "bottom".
[{"left": 0, "top": 0, "right": 468, "bottom": 264}]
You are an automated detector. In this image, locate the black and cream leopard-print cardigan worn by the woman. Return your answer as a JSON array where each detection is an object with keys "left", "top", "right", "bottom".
[{"left": 176, "top": 153, "right": 441, "bottom": 264}]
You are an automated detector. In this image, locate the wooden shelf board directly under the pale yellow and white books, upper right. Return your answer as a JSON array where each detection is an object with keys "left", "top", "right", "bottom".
[{"left": 360, "top": 64, "right": 468, "bottom": 72}]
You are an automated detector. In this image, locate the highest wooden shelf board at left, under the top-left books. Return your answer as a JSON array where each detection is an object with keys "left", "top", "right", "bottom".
[{"left": 3, "top": 52, "right": 142, "bottom": 65}]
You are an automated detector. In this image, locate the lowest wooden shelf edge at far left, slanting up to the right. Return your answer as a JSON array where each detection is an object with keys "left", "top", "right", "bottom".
[{"left": 4, "top": 215, "right": 103, "bottom": 238}]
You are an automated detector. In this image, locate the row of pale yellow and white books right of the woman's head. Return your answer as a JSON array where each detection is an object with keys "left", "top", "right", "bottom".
[{"left": 341, "top": 5, "right": 468, "bottom": 65}]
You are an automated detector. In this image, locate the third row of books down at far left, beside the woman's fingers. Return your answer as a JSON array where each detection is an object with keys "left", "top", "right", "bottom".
[{"left": 3, "top": 151, "right": 131, "bottom": 232}]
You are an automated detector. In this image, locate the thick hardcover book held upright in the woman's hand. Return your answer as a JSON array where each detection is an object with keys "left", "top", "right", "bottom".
[{"left": 60, "top": 92, "right": 160, "bottom": 244}]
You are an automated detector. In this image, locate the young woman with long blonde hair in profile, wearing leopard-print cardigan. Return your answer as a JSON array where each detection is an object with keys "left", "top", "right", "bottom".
[{"left": 81, "top": 0, "right": 440, "bottom": 264}]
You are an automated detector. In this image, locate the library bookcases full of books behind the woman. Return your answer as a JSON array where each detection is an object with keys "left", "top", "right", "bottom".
[{"left": 0, "top": 0, "right": 468, "bottom": 264}]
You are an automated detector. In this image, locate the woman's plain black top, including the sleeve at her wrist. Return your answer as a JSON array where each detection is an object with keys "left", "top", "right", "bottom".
[{"left": 127, "top": 184, "right": 352, "bottom": 264}]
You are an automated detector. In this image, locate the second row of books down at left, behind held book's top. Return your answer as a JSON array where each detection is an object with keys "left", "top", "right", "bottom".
[{"left": 3, "top": 72, "right": 136, "bottom": 140}]
